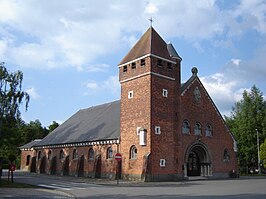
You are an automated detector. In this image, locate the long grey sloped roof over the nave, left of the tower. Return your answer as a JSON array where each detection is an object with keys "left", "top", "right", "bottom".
[{"left": 35, "top": 101, "right": 120, "bottom": 146}]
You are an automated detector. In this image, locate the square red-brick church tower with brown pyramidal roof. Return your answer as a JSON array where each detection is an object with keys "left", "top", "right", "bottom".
[{"left": 118, "top": 27, "right": 182, "bottom": 181}]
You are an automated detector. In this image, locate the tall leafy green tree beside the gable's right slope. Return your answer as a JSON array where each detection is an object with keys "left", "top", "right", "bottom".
[{"left": 225, "top": 86, "right": 266, "bottom": 172}]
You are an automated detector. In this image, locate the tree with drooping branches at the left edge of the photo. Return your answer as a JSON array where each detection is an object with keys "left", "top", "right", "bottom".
[{"left": 0, "top": 63, "right": 30, "bottom": 166}]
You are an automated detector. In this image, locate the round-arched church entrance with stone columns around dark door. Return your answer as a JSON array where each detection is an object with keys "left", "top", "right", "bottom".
[{"left": 184, "top": 142, "right": 212, "bottom": 177}]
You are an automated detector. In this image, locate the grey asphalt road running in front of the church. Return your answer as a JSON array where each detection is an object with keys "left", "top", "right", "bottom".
[{"left": 1, "top": 172, "right": 266, "bottom": 199}]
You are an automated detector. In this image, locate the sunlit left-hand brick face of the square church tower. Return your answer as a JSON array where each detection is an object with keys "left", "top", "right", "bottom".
[{"left": 120, "top": 58, "right": 151, "bottom": 178}]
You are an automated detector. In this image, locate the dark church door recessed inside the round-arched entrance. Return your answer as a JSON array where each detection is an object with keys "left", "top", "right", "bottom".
[{"left": 187, "top": 151, "right": 200, "bottom": 176}]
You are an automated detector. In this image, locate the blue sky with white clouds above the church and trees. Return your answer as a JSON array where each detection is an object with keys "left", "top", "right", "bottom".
[{"left": 0, "top": 0, "right": 266, "bottom": 126}]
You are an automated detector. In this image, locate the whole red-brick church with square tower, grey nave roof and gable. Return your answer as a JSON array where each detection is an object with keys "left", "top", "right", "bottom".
[{"left": 20, "top": 27, "right": 237, "bottom": 181}]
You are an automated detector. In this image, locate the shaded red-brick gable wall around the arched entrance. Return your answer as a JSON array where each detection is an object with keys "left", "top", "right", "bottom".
[{"left": 177, "top": 80, "right": 237, "bottom": 174}]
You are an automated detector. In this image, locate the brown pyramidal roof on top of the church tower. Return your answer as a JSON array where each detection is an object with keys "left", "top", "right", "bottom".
[{"left": 118, "top": 27, "right": 177, "bottom": 66}]
